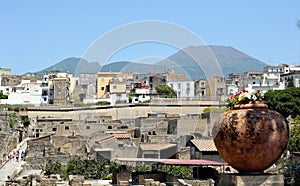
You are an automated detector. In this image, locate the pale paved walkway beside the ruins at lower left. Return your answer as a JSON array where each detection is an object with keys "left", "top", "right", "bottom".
[{"left": 0, "top": 138, "right": 29, "bottom": 185}]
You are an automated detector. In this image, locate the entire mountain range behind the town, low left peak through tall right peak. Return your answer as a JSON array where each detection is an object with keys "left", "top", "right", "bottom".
[{"left": 37, "top": 45, "right": 266, "bottom": 80}]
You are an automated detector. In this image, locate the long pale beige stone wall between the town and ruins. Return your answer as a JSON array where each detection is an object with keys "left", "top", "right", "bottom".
[{"left": 28, "top": 100, "right": 214, "bottom": 120}]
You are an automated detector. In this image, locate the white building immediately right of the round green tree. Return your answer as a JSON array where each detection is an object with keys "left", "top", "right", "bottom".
[{"left": 167, "top": 81, "right": 195, "bottom": 99}]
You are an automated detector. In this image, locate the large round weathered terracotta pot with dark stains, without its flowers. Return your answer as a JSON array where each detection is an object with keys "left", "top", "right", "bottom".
[{"left": 213, "top": 102, "right": 289, "bottom": 173}]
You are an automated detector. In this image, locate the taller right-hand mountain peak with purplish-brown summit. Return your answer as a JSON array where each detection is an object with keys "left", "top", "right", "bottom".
[{"left": 160, "top": 45, "right": 266, "bottom": 80}]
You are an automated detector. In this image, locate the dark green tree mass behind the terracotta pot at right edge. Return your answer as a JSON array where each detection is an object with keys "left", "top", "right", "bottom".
[{"left": 264, "top": 87, "right": 300, "bottom": 118}]
